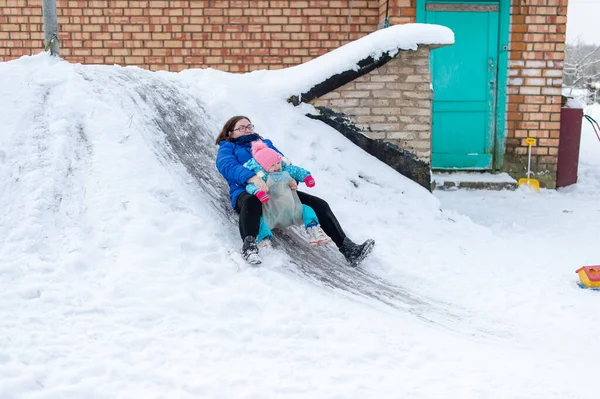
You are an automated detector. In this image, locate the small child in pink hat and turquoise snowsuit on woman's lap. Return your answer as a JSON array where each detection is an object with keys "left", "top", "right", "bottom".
[{"left": 244, "top": 140, "right": 331, "bottom": 245}]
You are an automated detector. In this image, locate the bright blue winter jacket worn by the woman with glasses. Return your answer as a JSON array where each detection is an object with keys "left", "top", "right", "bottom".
[{"left": 217, "top": 134, "right": 283, "bottom": 209}]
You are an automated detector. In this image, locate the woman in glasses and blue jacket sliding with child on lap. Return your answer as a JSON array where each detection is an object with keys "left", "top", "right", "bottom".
[{"left": 216, "top": 115, "right": 375, "bottom": 267}]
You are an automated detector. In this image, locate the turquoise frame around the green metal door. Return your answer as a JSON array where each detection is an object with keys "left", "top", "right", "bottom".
[{"left": 417, "top": 0, "right": 510, "bottom": 170}]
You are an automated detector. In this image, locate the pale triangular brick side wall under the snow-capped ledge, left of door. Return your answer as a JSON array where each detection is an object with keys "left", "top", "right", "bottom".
[{"left": 311, "top": 45, "right": 432, "bottom": 163}]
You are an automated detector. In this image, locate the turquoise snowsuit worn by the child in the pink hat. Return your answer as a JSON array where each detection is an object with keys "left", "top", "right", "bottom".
[{"left": 244, "top": 158, "right": 319, "bottom": 242}]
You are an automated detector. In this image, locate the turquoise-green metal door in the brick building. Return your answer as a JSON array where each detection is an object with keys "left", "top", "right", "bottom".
[{"left": 425, "top": 3, "right": 498, "bottom": 169}]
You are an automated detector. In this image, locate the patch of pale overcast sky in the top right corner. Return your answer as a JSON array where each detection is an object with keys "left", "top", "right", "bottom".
[{"left": 567, "top": 0, "right": 600, "bottom": 44}]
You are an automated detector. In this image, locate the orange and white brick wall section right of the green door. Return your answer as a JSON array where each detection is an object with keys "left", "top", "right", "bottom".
[{"left": 505, "top": 0, "right": 568, "bottom": 187}]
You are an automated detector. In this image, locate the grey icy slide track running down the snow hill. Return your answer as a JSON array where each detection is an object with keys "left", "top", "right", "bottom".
[{"left": 16, "top": 61, "right": 503, "bottom": 336}]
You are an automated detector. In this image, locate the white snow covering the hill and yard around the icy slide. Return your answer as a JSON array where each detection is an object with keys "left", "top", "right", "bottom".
[{"left": 0, "top": 32, "right": 600, "bottom": 399}]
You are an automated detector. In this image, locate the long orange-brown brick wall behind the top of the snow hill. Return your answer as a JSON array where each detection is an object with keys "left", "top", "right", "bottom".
[{"left": 0, "top": 0, "right": 381, "bottom": 72}]
